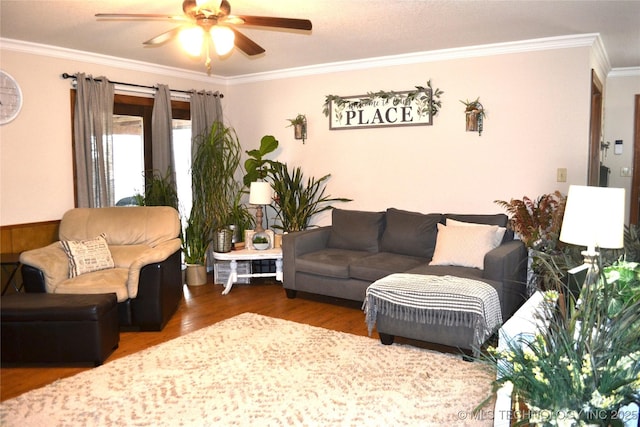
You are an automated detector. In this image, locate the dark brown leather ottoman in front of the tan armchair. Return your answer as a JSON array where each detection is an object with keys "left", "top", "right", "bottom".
[{"left": 0, "top": 293, "right": 120, "bottom": 366}]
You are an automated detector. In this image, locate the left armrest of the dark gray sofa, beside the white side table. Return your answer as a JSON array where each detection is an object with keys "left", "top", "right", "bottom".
[{"left": 282, "top": 226, "right": 331, "bottom": 289}]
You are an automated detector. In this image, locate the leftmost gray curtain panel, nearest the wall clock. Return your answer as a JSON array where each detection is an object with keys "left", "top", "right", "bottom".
[{"left": 73, "top": 73, "right": 114, "bottom": 208}]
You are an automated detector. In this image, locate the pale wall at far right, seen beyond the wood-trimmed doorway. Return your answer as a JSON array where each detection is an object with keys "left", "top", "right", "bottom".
[{"left": 602, "top": 69, "right": 640, "bottom": 224}]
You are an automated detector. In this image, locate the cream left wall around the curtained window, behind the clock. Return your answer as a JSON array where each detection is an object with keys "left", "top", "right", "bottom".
[{"left": 0, "top": 50, "right": 224, "bottom": 225}]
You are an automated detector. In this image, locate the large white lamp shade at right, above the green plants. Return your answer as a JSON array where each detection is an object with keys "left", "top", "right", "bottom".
[{"left": 560, "top": 185, "right": 625, "bottom": 252}]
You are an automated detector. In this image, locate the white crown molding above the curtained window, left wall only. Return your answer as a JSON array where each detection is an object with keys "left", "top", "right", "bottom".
[{"left": 0, "top": 38, "right": 226, "bottom": 85}]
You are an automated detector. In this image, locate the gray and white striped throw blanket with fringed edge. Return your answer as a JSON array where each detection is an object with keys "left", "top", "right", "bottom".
[{"left": 362, "top": 273, "right": 502, "bottom": 349}]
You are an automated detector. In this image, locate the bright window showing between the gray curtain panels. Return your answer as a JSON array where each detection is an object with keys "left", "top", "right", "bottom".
[{"left": 71, "top": 91, "right": 192, "bottom": 221}]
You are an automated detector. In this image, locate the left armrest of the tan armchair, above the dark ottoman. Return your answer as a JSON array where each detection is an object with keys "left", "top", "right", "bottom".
[{"left": 20, "top": 242, "right": 69, "bottom": 293}]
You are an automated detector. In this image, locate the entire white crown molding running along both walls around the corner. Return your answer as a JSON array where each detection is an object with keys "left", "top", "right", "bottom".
[{"left": 0, "top": 33, "right": 611, "bottom": 85}]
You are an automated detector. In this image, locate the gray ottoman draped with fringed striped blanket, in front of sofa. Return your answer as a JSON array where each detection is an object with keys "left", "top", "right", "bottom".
[{"left": 363, "top": 273, "right": 502, "bottom": 354}]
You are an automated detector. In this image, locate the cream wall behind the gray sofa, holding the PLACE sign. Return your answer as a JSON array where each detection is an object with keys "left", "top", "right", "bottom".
[{"left": 227, "top": 48, "right": 590, "bottom": 224}]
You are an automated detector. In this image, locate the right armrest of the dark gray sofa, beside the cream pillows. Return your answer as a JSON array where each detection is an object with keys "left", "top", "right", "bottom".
[{"left": 483, "top": 240, "right": 528, "bottom": 320}]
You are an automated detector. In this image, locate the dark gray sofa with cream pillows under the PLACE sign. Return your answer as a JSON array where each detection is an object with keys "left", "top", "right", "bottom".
[{"left": 282, "top": 208, "right": 527, "bottom": 349}]
